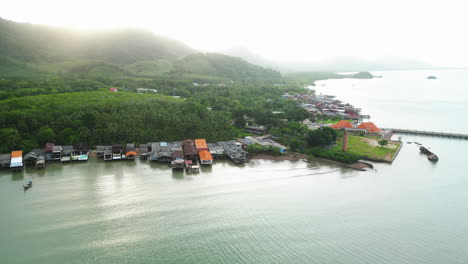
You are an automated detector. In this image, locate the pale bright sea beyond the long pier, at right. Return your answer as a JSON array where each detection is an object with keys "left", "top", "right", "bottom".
[{"left": 313, "top": 70, "right": 468, "bottom": 134}]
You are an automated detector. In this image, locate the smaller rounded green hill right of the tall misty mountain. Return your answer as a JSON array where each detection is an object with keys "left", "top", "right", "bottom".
[{"left": 170, "top": 53, "right": 282, "bottom": 82}]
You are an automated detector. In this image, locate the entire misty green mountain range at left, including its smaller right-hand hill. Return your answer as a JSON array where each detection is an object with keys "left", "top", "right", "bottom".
[{"left": 0, "top": 18, "right": 282, "bottom": 82}]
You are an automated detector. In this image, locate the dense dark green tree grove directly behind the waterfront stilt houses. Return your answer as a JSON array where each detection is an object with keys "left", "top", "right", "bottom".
[{"left": 0, "top": 92, "right": 238, "bottom": 151}]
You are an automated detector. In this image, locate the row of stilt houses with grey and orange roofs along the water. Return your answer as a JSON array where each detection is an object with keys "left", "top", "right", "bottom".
[{"left": 0, "top": 136, "right": 286, "bottom": 171}]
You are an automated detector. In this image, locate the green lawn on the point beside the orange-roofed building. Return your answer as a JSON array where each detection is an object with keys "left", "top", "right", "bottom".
[{"left": 332, "top": 135, "right": 401, "bottom": 161}]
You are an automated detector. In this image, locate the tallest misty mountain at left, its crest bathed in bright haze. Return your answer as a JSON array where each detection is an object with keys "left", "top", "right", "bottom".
[{"left": 0, "top": 18, "right": 194, "bottom": 64}]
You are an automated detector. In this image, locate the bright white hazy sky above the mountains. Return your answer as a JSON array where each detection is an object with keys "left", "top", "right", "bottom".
[{"left": 0, "top": 0, "right": 468, "bottom": 67}]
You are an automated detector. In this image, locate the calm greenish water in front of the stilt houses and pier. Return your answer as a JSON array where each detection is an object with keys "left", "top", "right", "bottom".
[{"left": 0, "top": 70, "right": 468, "bottom": 264}]
